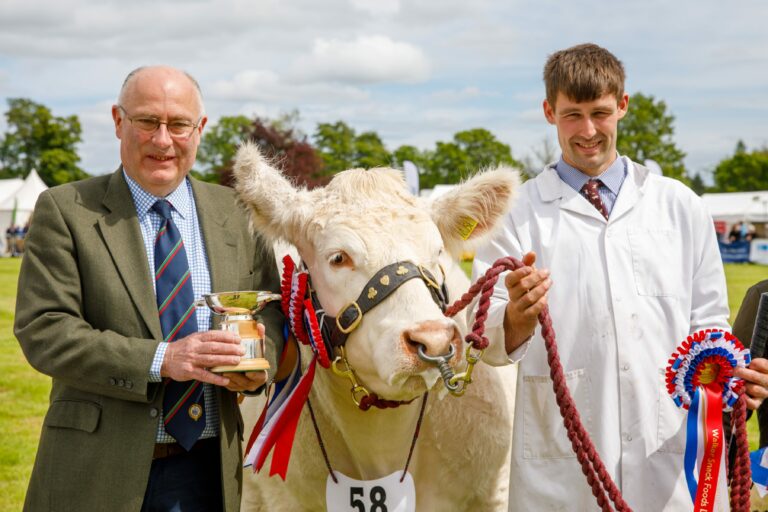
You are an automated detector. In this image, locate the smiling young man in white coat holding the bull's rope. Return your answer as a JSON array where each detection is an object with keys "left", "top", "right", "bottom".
[{"left": 473, "top": 44, "right": 768, "bottom": 511}]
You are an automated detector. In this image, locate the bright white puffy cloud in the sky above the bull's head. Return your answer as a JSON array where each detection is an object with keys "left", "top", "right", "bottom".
[{"left": 293, "top": 36, "right": 430, "bottom": 84}]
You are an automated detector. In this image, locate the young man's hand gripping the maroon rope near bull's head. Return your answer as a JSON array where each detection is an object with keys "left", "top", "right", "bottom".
[{"left": 504, "top": 252, "right": 552, "bottom": 354}]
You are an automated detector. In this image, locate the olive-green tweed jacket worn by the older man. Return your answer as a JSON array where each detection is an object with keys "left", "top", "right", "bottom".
[{"left": 14, "top": 169, "right": 283, "bottom": 511}]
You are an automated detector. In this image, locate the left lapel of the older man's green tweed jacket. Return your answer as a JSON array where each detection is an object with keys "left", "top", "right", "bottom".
[{"left": 99, "top": 167, "right": 163, "bottom": 340}]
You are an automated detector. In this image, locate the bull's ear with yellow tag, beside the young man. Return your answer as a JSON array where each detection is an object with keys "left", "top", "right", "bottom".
[{"left": 431, "top": 167, "right": 520, "bottom": 256}]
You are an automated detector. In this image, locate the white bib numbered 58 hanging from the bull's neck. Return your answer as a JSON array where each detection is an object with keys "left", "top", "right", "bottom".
[{"left": 325, "top": 471, "right": 416, "bottom": 512}]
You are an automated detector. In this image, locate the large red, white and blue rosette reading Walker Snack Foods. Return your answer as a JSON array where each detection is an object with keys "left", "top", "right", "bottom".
[{"left": 666, "top": 329, "right": 750, "bottom": 512}]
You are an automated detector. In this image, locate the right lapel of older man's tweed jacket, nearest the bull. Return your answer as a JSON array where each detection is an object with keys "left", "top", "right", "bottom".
[{"left": 190, "top": 179, "right": 242, "bottom": 292}]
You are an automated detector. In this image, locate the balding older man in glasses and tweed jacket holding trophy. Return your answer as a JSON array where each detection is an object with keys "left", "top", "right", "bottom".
[{"left": 14, "top": 66, "right": 284, "bottom": 512}]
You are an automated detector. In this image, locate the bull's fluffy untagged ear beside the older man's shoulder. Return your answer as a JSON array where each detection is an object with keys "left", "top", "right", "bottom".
[{"left": 233, "top": 142, "right": 312, "bottom": 245}]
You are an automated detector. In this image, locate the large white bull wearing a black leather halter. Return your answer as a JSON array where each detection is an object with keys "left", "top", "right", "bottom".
[{"left": 235, "top": 145, "right": 518, "bottom": 512}]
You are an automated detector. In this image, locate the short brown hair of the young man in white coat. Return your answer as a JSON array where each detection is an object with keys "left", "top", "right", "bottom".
[{"left": 544, "top": 43, "right": 624, "bottom": 108}]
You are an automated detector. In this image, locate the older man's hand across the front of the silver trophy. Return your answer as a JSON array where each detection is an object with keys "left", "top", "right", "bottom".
[{"left": 160, "top": 331, "right": 245, "bottom": 386}]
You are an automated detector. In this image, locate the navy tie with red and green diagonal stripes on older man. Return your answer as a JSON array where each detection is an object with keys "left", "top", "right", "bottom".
[{"left": 152, "top": 199, "right": 205, "bottom": 450}]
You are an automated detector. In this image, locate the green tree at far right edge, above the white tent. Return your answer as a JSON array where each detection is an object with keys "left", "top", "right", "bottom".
[{"left": 714, "top": 141, "right": 768, "bottom": 192}]
